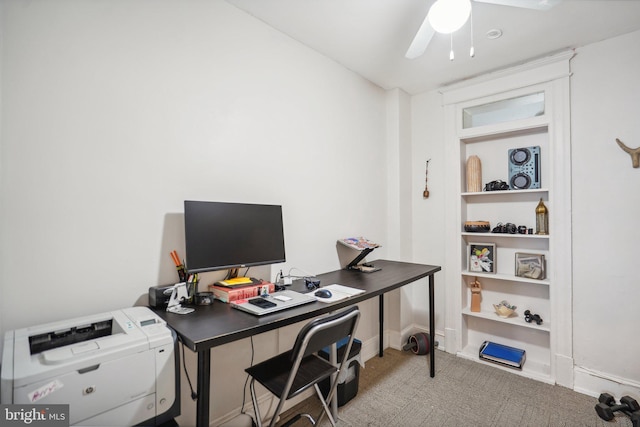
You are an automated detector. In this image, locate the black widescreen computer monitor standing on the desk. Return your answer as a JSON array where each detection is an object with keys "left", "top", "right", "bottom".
[{"left": 184, "top": 200, "right": 286, "bottom": 278}]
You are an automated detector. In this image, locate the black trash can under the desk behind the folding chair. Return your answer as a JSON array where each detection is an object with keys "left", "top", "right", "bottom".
[{"left": 318, "top": 338, "right": 362, "bottom": 406}]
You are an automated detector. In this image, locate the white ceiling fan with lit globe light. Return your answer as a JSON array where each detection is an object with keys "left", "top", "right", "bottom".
[{"left": 405, "top": 0, "right": 562, "bottom": 59}]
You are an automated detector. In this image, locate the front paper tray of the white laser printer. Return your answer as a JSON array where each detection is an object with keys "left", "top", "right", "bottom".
[{"left": 14, "top": 351, "right": 156, "bottom": 425}]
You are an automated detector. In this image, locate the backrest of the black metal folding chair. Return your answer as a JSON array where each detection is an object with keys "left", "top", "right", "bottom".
[{"left": 291, "top": 306, "right": 360, "bottom": 360}]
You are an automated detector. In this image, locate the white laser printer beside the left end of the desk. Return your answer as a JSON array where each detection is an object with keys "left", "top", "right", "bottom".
[{"left": 0, "top": 307, "right": 180, "bottom": 427}]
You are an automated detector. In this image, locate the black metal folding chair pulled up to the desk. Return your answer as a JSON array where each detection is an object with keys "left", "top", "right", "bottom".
[{"left": 245, "top": 306, "right": 360, "bottom": 427}]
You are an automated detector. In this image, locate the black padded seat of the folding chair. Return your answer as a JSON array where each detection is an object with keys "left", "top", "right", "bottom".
[{"left": 245, "top": 350, "right": 338, "bottom": 399}]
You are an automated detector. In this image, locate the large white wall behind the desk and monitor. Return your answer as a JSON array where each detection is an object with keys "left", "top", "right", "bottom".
[{"left": 0, "top": 0, "right": 394, "bottom": 425}]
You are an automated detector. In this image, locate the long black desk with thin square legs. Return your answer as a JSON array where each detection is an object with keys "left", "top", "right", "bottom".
[{"left": 155, "top": 260, "right": 441, "bottom": 427}]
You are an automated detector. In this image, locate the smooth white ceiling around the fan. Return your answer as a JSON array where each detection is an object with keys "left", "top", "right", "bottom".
[{"left": 227, "top": 0, "right": 640, "bottom": 94}]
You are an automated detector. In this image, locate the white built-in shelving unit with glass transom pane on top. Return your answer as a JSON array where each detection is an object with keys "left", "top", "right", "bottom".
[{"left": 444, "top": 52, "right": 573, "bottom": 386}]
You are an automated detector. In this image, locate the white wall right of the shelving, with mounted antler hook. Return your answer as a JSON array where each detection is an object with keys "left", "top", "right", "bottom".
[{"left": 571, "top": 32, "right": 640, "bottom": 396}]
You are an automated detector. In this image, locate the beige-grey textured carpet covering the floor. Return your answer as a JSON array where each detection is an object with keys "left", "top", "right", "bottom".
[{"left": 280, "top": 349, "right": 631, "bottom": 427}]
